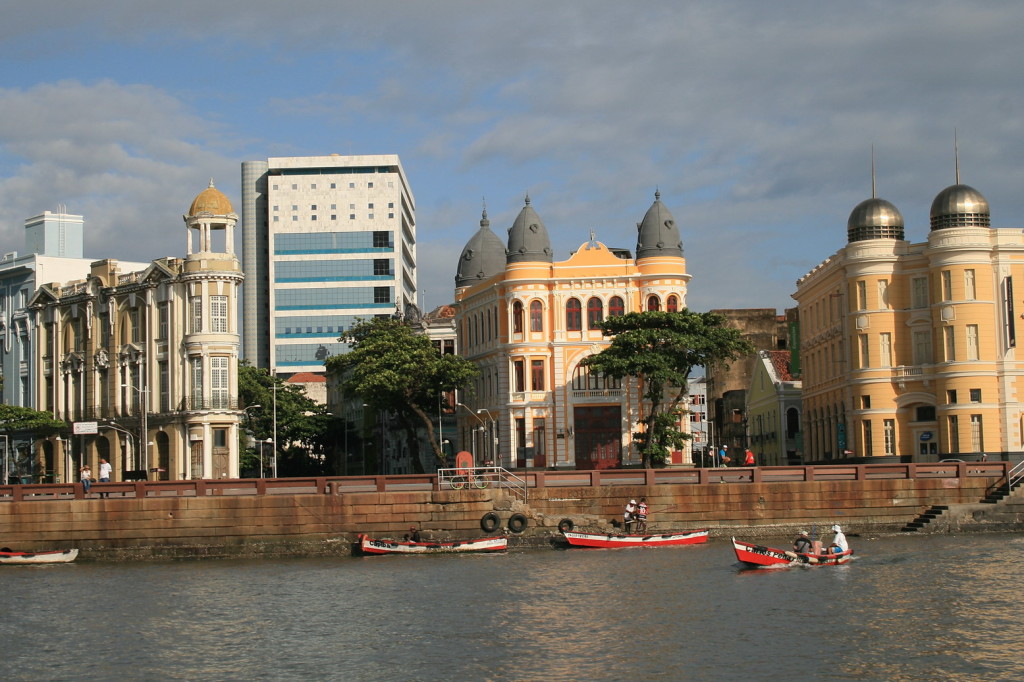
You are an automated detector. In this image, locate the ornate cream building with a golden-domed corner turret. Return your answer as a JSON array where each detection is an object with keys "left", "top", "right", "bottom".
[{"left": 30, "top": 181, "right": 243, "bottom": 481}]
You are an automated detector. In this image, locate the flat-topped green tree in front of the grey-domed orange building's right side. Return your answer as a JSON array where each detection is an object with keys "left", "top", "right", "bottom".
[{"left": 582, "top": 309, "right": 754, "bottom": 467}]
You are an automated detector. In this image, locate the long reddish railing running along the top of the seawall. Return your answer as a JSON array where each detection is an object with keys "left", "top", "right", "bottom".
[{"left": 0, "top": 462, "right": 1011, "bottom": 502}]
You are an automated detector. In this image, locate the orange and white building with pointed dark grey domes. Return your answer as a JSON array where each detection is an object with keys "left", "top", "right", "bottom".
[{"left": 456, "top": 194, "right": 691, "bottom": 469}]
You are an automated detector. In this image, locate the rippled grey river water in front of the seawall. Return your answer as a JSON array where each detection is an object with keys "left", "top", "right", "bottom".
[{"left": 0, "top": 535, "right": 1024, "bottom": 681}]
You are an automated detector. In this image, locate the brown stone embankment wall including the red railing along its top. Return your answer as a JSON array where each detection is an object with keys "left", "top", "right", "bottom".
[{"left": 0, "top": 462, "right": 1015, "bottom": 557}]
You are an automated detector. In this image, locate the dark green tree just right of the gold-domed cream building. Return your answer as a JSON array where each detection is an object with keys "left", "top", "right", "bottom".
[{"left": 239, "top": 363, "right": 339, "bottom": 476}]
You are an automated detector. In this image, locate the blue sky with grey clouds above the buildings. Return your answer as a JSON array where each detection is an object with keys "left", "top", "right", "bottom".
[{"left": 0, "top": 0, "right": 1024, "bottom": 312}]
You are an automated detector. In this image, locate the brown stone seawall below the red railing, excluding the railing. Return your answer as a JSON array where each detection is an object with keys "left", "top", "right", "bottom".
[{"left": 0, "top": 477, "right": 1011, "bottom": 559}]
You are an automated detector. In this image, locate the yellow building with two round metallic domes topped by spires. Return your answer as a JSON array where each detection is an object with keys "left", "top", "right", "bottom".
[{"left": 794, "top": 177, "right": 1024, "bottom": 462}]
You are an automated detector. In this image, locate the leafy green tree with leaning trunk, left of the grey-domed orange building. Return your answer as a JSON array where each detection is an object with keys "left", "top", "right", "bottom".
[{"left": 327, "top": 317, "right": 477, "bottom": 473}]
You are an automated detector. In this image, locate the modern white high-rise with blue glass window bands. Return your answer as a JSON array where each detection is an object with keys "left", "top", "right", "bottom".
[{"left": 242, "top": 155, "right": 417, "bottom": 375}]
